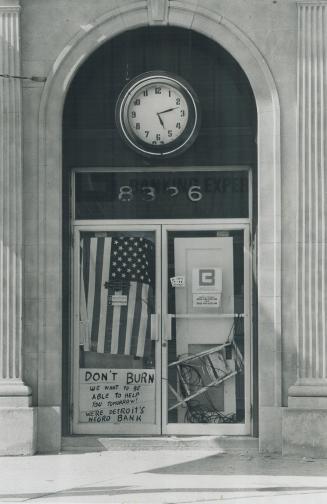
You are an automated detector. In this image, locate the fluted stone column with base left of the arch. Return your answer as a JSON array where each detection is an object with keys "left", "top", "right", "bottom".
[{"left": 0, "top": 0, "right": 33, "bottom": 454}]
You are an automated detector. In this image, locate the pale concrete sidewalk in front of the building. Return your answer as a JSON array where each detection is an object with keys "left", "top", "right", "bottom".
[{"left": 0, "top": 449, "right": 327, "bottom": 504}]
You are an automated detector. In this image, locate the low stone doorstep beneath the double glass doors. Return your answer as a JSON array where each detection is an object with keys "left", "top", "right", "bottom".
[{"left": 61, "top": 435, "right": 259, "bottom": 453}]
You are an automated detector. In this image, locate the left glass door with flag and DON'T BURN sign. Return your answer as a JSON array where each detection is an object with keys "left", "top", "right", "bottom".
[{"left": 72, "top": 224, "right": 161, "bottom": 434}]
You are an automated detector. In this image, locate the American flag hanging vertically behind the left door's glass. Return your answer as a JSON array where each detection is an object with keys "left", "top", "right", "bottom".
[{"left": 80, "top": 235, "right": 155, "bottom": 357}]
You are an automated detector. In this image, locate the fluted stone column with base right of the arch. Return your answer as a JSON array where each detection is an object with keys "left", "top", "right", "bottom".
[{"left": 284, "top": 0, "right": 327, "bottom": 456}]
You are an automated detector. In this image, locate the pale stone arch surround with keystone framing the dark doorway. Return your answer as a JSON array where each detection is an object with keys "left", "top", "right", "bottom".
[{"left": 38, "top": 0, "right": 281, "bottom": 451}]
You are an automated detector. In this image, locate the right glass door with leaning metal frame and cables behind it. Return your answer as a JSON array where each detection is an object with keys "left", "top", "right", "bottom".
[{"left": 162, "top": 224, "right": 251, "bottom": 435}]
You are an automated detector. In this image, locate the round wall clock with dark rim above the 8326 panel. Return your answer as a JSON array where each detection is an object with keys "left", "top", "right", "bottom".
[{"left": 116, "top": 71, "right": 200, "bottom": 157}]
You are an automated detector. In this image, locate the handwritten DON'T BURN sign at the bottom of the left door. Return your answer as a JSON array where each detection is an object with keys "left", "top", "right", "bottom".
[{"left": 79, "top": 368, "right": 155, "bottom": 424}]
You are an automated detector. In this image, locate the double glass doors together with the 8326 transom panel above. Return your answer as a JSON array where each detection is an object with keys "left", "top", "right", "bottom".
[{"left": 71, "top": 166, "right": 252, "bottom": 435}]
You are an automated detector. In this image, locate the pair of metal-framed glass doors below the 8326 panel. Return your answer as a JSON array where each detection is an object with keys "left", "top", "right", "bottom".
[{"left": 71, "top": 221, "right": 251, "bottom": 435}]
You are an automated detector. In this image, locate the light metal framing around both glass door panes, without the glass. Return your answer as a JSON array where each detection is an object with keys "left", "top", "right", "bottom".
[{"left": 70, "top": 219, "right": 253, "bottom": 436}]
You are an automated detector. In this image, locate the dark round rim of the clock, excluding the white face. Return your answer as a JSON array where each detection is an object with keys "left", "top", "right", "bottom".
[{"left": 115, "top": 70, "right": 201, "bottom": 157}]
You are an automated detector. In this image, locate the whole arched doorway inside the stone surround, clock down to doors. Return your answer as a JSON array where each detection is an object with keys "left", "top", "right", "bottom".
[{"left": 63, "top": 27, "right": 257, "bottom": 434}]
